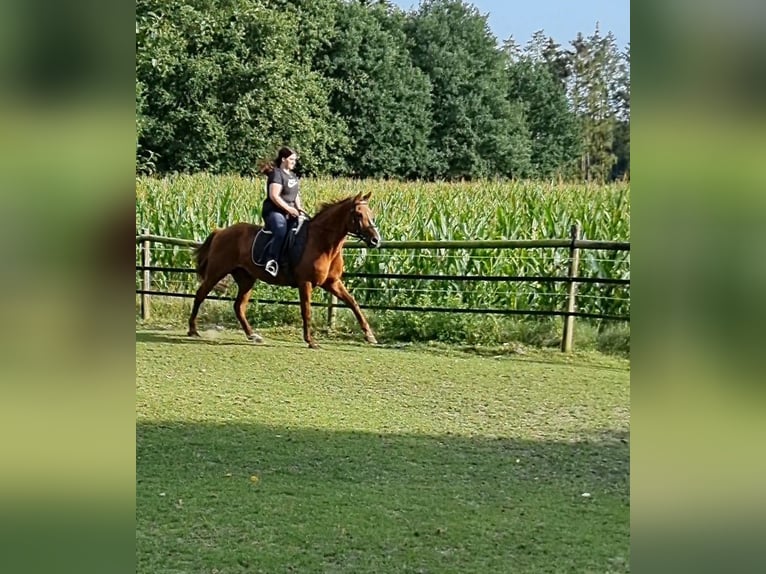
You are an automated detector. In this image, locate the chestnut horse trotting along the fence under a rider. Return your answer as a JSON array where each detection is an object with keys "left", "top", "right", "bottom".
[{"left": 188, "top": 193, "right": 381, "bottom": 349}]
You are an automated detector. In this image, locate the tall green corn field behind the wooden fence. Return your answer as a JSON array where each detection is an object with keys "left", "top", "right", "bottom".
[{"left": 136, "top": 175, "right": 630, "bottom": 315}]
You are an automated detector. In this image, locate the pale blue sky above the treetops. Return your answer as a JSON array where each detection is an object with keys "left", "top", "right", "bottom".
[{"left": 394, "top": 0, "right": 630, "bottom": 48}]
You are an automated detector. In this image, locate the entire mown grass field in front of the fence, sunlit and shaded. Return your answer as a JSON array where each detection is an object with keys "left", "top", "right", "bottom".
[{"left": 136, "top": 329, "right": 630, "bottom": 573}]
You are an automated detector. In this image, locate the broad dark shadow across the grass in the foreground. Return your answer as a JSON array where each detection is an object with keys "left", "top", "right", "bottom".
[{"left": 136, "top": 422, "right": 629, "bottom": 573}]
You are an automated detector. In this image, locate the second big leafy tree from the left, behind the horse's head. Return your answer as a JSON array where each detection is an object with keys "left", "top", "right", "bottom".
[{"left": 317, "top": 2, "right": 431, "bottom": 177}]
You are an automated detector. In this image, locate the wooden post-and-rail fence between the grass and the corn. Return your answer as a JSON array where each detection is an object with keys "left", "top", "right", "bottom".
[{"left": 136, "top": 225, "right": 630, "bottom": 352}]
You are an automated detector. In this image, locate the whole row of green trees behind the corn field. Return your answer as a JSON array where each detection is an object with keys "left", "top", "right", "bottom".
[{"left": 136, "top": 0, "right": 630, "bottom": 181}]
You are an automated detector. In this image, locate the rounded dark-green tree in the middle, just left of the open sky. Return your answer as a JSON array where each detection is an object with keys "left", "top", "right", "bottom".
[{"left": 406, "top": 0, "right": 530, "bottom": 179}]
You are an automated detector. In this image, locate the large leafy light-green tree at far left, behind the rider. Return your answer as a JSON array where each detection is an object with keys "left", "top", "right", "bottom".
[{"left": 136, "top": 0, "right": 342, "bottom": 173}]
